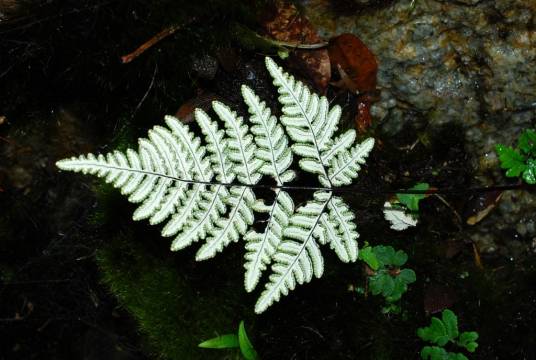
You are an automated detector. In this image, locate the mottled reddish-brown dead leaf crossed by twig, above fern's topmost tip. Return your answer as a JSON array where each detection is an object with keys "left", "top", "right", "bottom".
[{"left": 262, "top": 1, "right": 331, "bottom": 93}]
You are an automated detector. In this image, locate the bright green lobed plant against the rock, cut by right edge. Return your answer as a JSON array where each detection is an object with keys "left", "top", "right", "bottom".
[{"left": 495, "top": 129, "right": 536, "bottom": 185}]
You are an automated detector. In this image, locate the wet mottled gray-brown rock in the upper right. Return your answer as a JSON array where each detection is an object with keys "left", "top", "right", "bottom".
[{"left": 305, "top": 0, "right": 536, "bottom": 252}]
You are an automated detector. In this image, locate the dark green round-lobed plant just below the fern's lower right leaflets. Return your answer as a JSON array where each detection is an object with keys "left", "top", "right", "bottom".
[{"left": 359, "top": 245, "right": 416, "bottom": 312}]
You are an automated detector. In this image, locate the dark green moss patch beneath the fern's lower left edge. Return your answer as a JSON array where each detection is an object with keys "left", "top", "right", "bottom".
[{"left": 97, "top": 234, "right": 252, "bottom": 360}]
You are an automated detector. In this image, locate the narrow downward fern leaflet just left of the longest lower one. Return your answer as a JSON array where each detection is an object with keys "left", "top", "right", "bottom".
[{"left": 244, "top": 190, "right": 294, "bottom": 292}]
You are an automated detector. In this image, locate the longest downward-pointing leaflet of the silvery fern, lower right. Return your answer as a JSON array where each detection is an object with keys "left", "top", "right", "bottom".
[{"left": 255, "top": 192, "right": 331, "bottom": 313}]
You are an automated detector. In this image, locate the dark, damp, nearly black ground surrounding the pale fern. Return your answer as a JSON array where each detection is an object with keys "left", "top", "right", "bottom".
[{"left": 0, "top": 0, "right": 536, "bottom": 359}]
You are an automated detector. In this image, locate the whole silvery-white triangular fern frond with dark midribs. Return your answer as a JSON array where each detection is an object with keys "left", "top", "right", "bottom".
[{"left": 57, "top": 58, "right": 374, "bottom": 313}]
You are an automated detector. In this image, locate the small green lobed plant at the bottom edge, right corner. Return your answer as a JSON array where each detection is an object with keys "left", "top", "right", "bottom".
[{"left": 417, "top": 309, "right": 478, "bottom": 360}]
